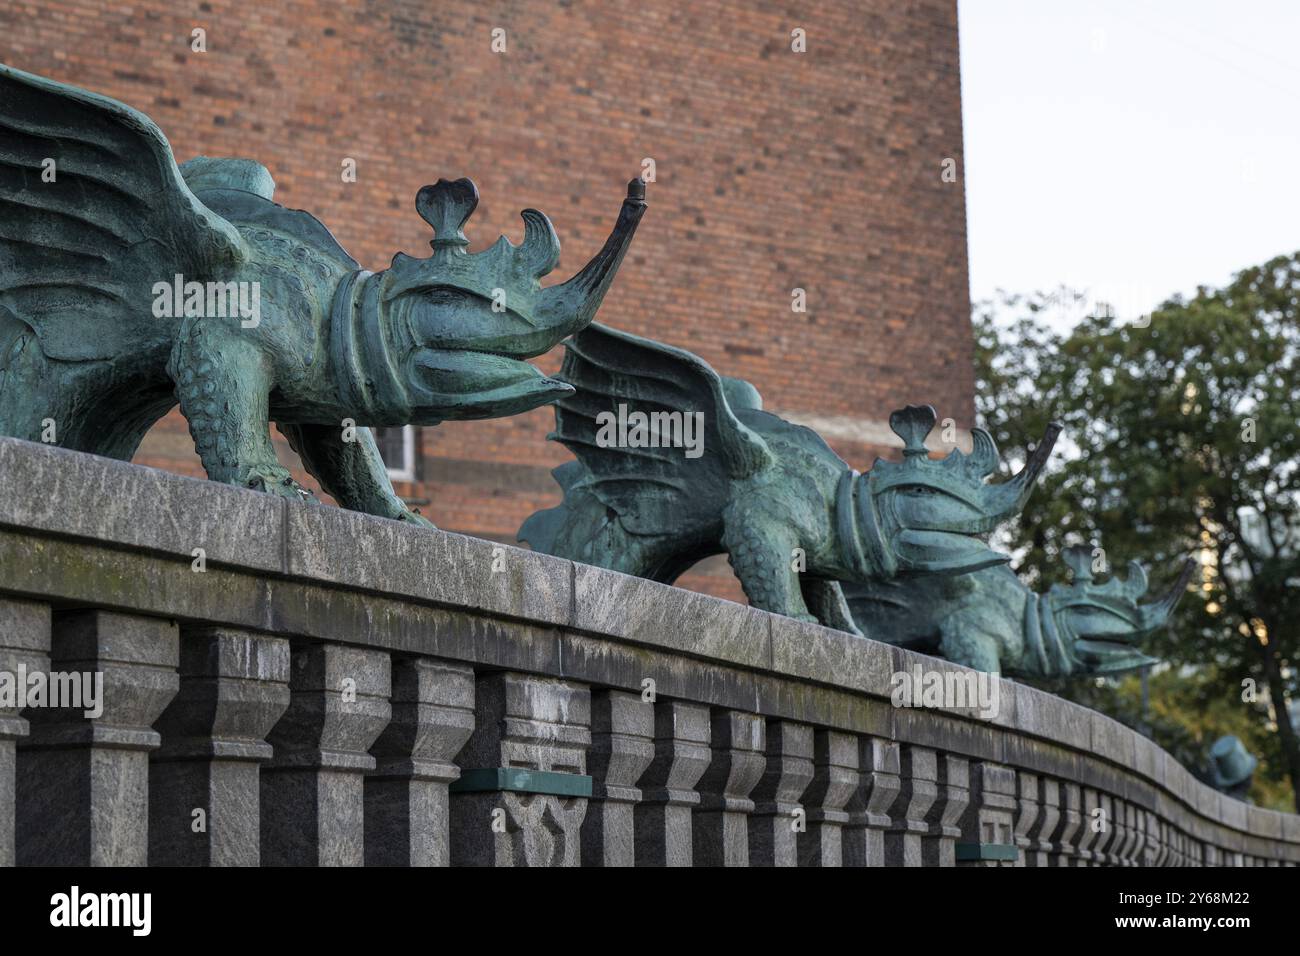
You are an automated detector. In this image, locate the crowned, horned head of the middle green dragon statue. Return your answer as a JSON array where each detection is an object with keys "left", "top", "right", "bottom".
[{"left": 840, "top": 405, "right": 1061, "bottom": 579}]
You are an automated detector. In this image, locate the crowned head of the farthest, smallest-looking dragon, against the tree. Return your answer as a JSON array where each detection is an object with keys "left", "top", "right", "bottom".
[{"left": 1040, "top": 546, "right": 1196, "bottom": 674}]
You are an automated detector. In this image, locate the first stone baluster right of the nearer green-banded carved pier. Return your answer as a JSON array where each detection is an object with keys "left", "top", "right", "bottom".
[{"left": 581, "top": 691, "right": 654, "bottom": 866}]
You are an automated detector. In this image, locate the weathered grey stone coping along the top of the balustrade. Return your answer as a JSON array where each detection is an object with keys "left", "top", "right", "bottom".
[{"left": 0, "top": 437, "right": 1300, "bottom": 858}]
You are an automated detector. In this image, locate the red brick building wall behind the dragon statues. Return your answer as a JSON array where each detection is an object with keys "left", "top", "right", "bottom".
[{"left": 0, "top": 0, "right": 972, "bottom": 606}]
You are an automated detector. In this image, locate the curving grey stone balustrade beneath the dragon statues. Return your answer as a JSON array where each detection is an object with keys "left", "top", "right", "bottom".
[{"left": 0, "top": 438, "right": 1300, "bottom": 866}]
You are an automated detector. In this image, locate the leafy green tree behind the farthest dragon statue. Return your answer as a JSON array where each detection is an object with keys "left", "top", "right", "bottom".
[{"left": 975, "top": 254, "right": 1300, "bottom": 810}]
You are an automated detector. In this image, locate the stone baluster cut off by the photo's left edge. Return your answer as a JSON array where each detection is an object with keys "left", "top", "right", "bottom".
[{"left": 0, "top": 597, "right": 49, "bottom": 866}]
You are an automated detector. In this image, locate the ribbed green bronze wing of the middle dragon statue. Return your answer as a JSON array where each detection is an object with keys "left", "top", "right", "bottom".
[{"left": 551, "top": 324, "right": 772, "bottom": 535}]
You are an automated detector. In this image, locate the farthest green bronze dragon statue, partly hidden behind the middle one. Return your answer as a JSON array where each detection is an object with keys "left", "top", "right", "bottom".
[{"left": 845, "top": 546, "right": 1196, "bottom": 678}]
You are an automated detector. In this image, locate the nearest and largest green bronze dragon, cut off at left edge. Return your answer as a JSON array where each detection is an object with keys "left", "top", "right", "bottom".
[{"left": 0, "top": 65, "right": 645, "bottom": 524}]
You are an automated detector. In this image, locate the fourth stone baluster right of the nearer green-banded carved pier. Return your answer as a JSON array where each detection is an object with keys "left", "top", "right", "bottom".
[{"left": 749, "top": 721, "right": 813, "bottom": 866}]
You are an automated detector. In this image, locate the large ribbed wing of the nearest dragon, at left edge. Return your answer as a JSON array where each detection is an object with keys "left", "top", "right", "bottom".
[{"left": 0, "top": 64, "right": 247, "bottom": 360}]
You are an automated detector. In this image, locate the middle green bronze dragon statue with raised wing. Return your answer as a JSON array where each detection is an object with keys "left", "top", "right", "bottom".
[{"left": 519, "top": 324, "right": 1060, "bottom": 633}]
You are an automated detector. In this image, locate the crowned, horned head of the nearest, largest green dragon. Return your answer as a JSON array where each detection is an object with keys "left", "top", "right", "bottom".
[{"left": 330, "top": 178, "right": 646, "bottom": 424}]
